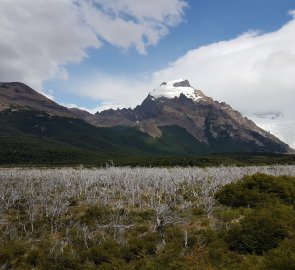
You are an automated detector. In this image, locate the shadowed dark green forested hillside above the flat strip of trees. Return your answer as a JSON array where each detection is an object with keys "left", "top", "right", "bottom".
[{"left": 0, "top": 108, "right": 215, "bottom": 165}]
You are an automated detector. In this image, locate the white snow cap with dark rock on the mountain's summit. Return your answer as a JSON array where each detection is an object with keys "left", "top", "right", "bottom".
[{"left": 150, "top": 79, "right": 204, "bottom": 101}]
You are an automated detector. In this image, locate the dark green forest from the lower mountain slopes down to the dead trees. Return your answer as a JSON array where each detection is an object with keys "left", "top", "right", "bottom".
[{"left": 0, "top": 107, "right": 295, "bottom": 167}]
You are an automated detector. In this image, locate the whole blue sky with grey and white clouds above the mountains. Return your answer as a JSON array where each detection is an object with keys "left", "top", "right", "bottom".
[{"left": 0, "top": 0, "right": 295, "bottom": 115}]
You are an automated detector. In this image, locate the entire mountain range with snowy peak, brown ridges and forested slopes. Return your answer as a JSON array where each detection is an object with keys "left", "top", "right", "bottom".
[{"left": 0, "top": 80, "right": 293, "bottom": 164}]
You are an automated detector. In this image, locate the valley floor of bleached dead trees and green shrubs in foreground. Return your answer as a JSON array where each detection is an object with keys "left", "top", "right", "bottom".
[{"left": 0, "top": 165, "right": 295, "bottom": 270}]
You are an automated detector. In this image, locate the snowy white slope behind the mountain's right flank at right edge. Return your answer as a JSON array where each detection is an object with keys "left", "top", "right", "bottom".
[{"left": 247, "top": 112, "right": 295, "bottom": 149}]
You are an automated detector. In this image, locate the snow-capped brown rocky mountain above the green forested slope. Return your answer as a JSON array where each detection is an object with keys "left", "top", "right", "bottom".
[{"left": 95, "top": 80, "right": 293, "bottom": 153}]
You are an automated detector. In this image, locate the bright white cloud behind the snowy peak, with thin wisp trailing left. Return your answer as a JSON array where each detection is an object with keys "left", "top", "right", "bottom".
[{"left": 72, "top": 12, "right": 295, "bottom": 114}]
